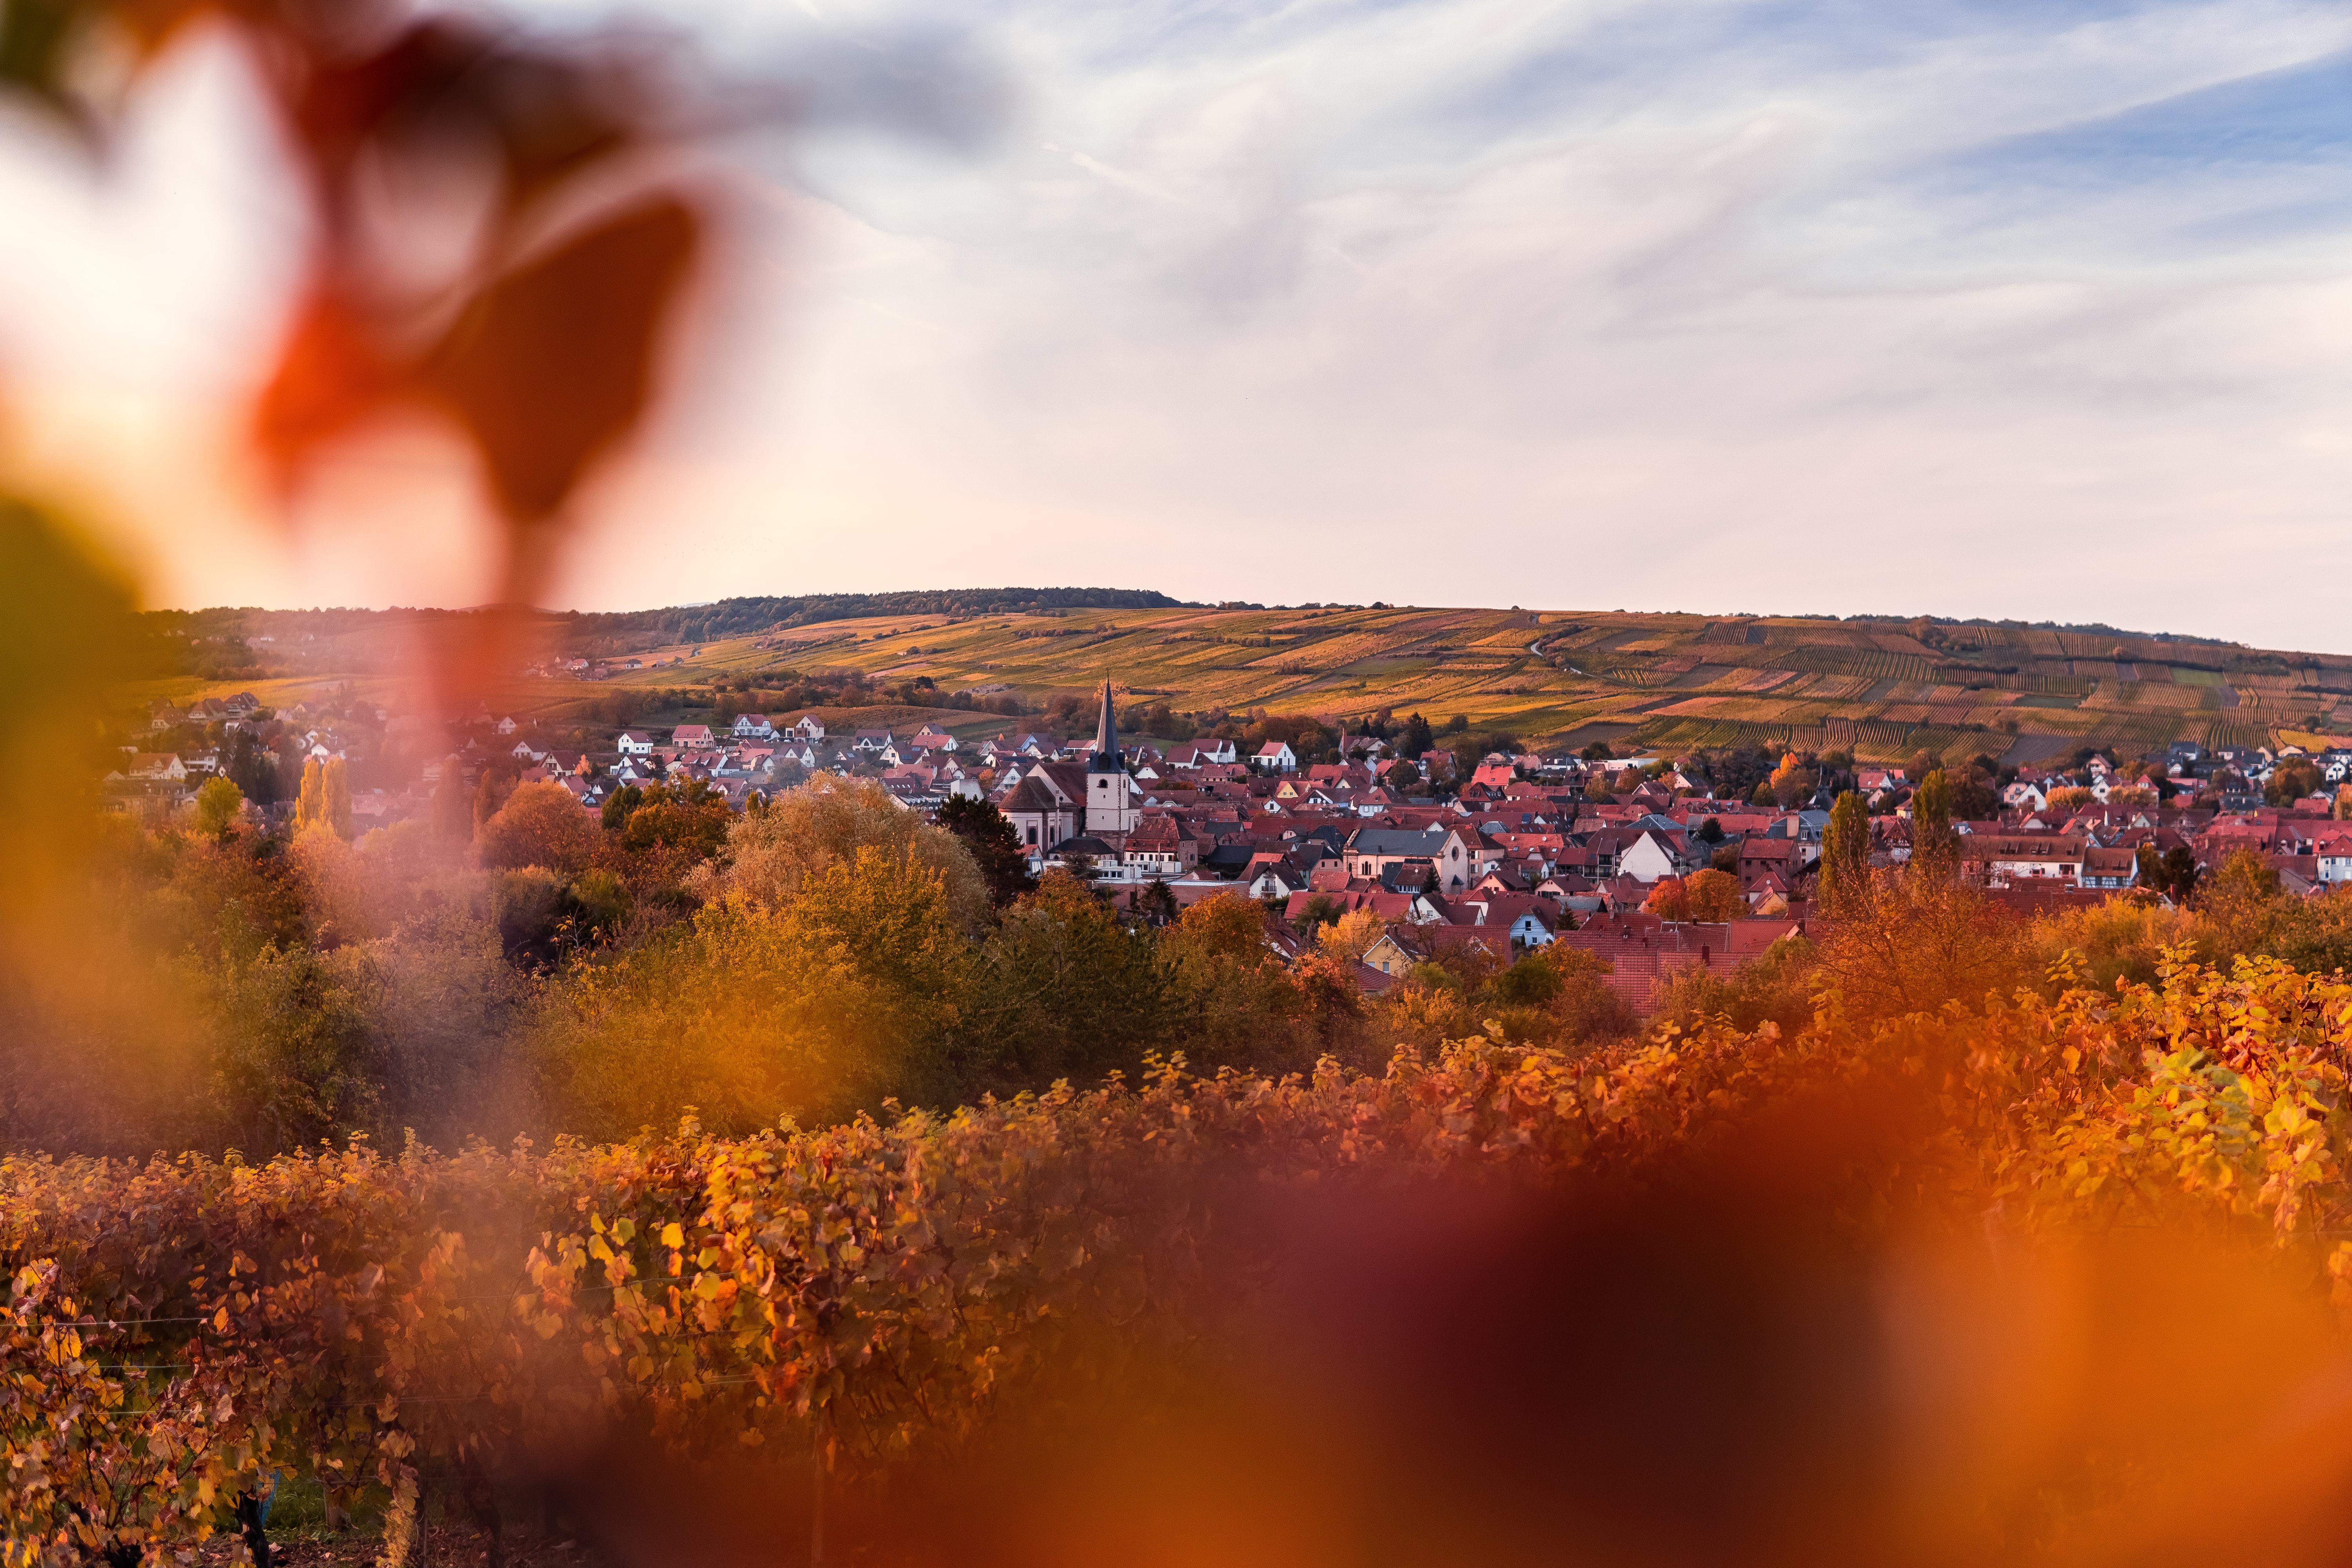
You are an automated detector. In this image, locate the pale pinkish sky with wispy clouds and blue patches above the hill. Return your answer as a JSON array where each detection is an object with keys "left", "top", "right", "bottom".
[{"left": 0, "top": 0, "right": 2352, "bottom": 651}]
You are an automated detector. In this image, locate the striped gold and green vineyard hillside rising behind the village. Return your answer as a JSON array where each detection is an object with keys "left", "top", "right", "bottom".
[{"left": 153, "top": 606, "right": 2352, "bottom": 759}]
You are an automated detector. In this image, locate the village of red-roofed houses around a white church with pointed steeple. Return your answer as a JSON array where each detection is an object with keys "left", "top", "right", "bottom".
[{"left": 106, "top": 682, "right": 2352, "bottom": 1006}]
